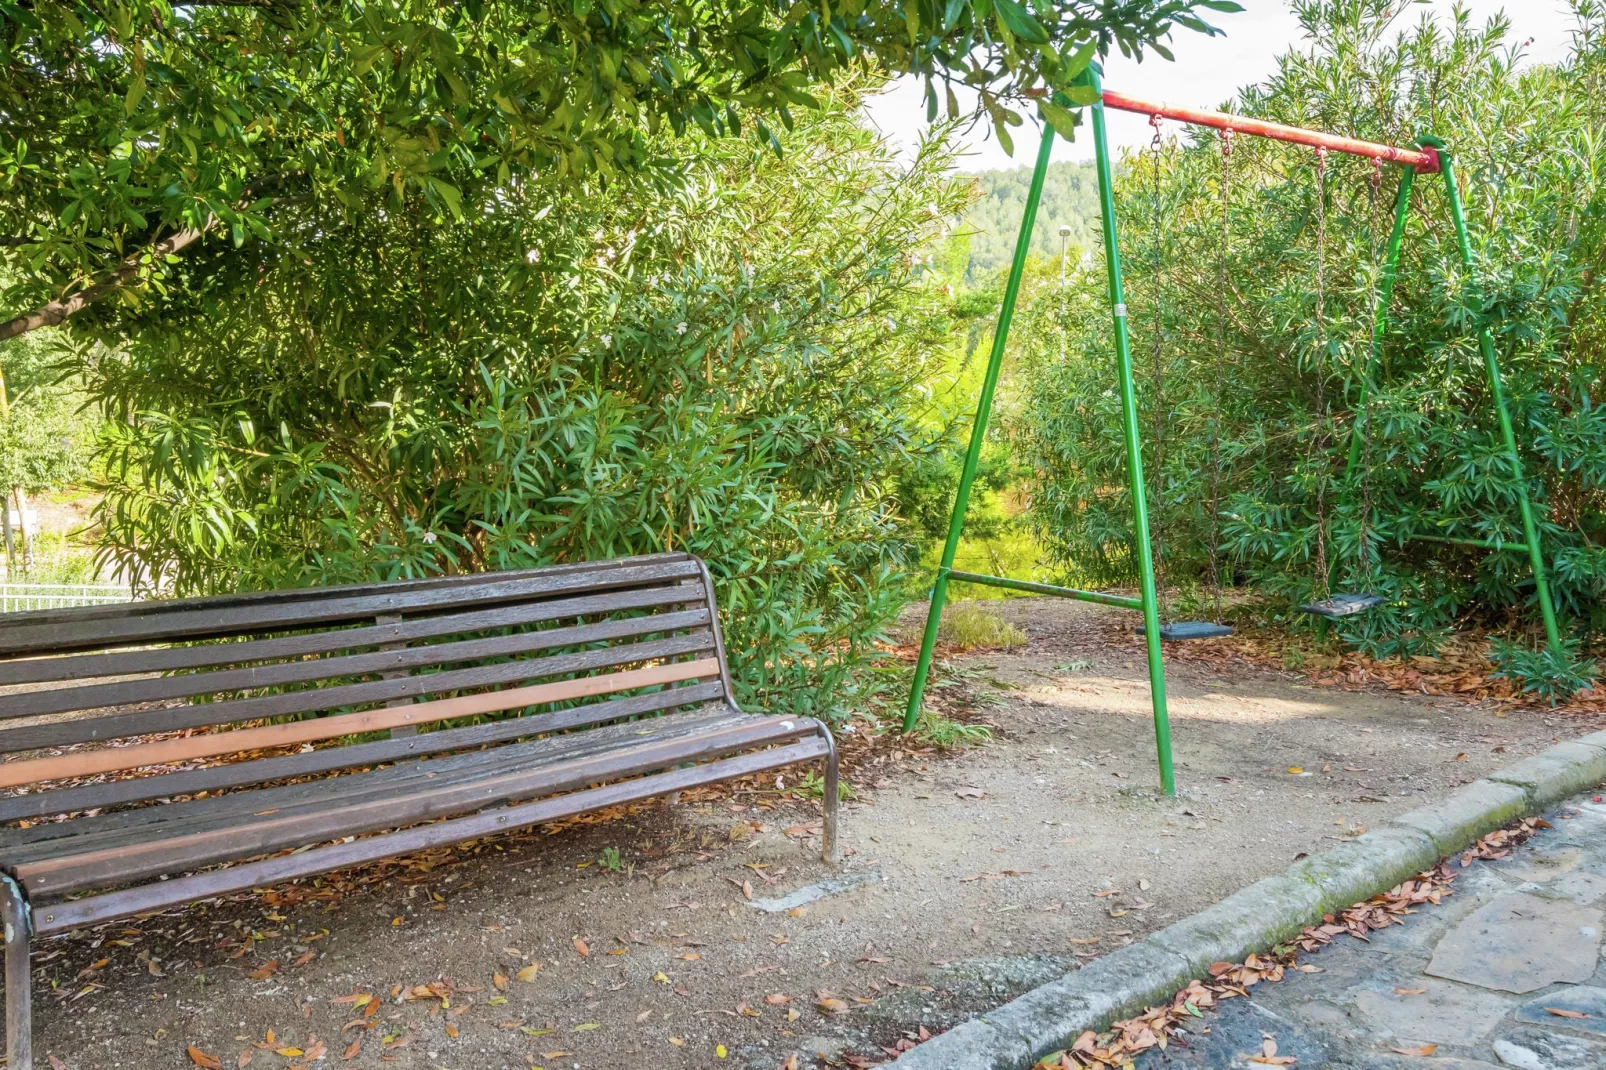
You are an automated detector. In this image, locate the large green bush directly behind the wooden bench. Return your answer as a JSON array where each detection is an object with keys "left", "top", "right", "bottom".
[{"left": 90, "top": 87, "right": 968, "bottom": 713}]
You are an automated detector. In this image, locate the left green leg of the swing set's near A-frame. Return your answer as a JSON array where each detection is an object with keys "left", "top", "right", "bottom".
[{"left": 904, "top": 124, "right": 1054, "bottom": 733}]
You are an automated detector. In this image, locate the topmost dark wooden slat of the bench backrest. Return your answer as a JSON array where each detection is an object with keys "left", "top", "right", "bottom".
[{"left": 0, "top": 561, "right": 697, "bottom": 655}]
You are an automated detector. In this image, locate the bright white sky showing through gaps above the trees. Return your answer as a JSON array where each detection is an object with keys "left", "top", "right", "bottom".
[{"left": 867, "top": 0, "right": 1572, "bottom": 170}]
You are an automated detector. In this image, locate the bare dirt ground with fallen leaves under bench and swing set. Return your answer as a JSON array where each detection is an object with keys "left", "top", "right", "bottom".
[{"left": 18, "top": 599, "right": 1598, "bottom": 1070}]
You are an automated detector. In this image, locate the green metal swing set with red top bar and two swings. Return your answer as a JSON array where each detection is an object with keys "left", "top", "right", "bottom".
[{"left": 904, "top": 64, "right": 1561, "bottom": 795}]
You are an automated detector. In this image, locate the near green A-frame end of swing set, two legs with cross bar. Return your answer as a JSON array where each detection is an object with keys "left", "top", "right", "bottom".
[{"left": 904, "top": 64, "right": 1177, "bottom": 795}]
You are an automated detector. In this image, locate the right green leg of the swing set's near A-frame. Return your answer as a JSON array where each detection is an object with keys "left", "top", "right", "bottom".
[{"left": 1082, "top": 64, "right": 1177, "bottom": 795}]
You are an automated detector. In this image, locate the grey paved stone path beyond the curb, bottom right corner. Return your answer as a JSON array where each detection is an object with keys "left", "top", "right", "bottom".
[{"left": 1139, "top": 795, "right": 1606, "bottom": 1070}]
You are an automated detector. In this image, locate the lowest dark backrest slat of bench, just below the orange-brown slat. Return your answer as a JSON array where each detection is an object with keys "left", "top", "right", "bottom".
[{"left": 0, "top": 683, "right": 724, "bottom": 824}]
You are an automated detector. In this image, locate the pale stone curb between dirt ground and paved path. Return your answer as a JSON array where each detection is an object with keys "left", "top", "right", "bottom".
[{"left": 891, "top": 733, "right": 1606, "bottom": 1070}]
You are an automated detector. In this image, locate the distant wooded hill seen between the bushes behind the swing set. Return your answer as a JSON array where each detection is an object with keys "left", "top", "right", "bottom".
[{"left": 965, "top": 162, "right": 1099, "bottom": 283}]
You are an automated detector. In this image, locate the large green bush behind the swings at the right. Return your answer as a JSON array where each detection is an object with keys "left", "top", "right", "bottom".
[{"left": 1015, "top": 0, "right": 1606, "bottom": 654}]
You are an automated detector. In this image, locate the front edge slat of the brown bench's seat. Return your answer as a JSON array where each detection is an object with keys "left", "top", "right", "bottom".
[{"left": 34, "top": 737, "right": 829, "bottom": 937}]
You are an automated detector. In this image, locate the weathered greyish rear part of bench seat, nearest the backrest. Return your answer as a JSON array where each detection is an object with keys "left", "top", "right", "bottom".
[{"left": 0, "top": 707, "right": 758, "bottom": 868}]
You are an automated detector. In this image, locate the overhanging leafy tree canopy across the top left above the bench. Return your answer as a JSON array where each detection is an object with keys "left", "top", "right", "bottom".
[{"left": 0, "top": 0, "right": 1237, "bottom": 341}]
